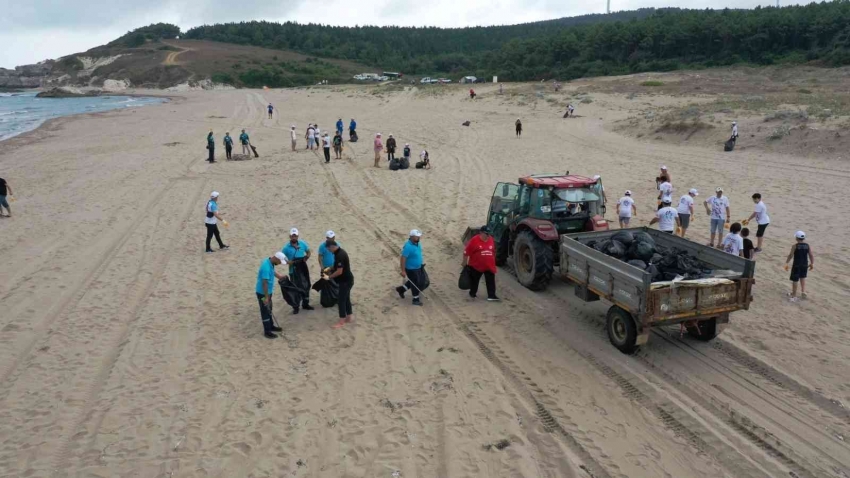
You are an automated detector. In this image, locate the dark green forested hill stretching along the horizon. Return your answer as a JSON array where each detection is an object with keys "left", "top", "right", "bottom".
[{"left": 185, "top": 0, "right": 850, "bottom": 81}]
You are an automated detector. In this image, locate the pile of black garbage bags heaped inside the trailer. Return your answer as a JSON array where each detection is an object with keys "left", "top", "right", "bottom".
[{"left": 585, "top": 231, "right": 713, "bottom": 282}]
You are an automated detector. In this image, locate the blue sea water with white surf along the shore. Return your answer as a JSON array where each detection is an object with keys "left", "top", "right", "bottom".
[{"left": 0, "top": 91, "right": 167, "bottom": 141}]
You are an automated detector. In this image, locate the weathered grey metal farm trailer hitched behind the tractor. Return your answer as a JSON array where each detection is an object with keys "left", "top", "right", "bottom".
[{"left": 559, "top": 227, "right": 755, "bottom": 353}]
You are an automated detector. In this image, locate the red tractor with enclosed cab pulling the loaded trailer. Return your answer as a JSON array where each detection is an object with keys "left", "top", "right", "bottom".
[{"left": 463, "top": 172, "right": 608, "bottom": 290}]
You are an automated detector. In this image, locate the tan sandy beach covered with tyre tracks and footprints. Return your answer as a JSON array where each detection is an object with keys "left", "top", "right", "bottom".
[{"left": 0, "top": 82, "right": 850, "bottom": 478}]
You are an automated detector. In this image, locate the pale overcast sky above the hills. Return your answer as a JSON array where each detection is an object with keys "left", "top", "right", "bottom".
[{"left": 0, "top": 0, "right": 807, "bottom": 68}]
